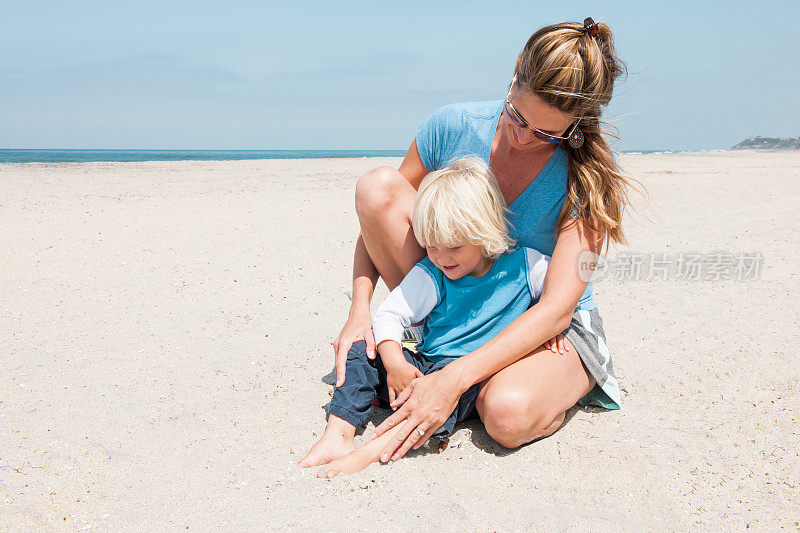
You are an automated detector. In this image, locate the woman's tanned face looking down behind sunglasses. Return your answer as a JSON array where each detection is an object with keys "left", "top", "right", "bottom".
[{"left": 502, "top": 83, "right": 574, "bottom": 150}]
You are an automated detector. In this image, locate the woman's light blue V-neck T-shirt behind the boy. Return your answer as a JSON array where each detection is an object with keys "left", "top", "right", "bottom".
[{"left": 416, "top": 100, "right": 597, "bottom": 311}]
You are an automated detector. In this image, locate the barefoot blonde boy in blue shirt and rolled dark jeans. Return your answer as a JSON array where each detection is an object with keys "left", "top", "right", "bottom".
[{"left": 298, "top": 158, "right": 550, "bottom": 477}]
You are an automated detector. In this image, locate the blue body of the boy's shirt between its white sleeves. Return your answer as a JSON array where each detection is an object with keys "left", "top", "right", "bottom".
[{"left": 417, "top": 247, "right": 541, "bottom": 361}]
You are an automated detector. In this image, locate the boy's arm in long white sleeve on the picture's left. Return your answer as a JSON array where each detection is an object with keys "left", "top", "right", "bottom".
[{"left": 372, "top": 265, "right": 439, "bottom": 365}]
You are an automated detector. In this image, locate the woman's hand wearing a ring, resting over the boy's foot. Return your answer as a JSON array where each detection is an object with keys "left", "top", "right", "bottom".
[{"left": 370, "top": 365, "right": 463, "bottom": 462}]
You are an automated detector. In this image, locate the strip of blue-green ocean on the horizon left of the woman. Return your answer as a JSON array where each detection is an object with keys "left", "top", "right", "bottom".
[{"left": 0, "top": 149, "right": 406, "bottom": 163}]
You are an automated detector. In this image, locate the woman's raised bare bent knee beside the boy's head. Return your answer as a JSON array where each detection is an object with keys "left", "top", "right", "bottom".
[{"left": 356, "top": 167, "right": 426, "bottom": 290}]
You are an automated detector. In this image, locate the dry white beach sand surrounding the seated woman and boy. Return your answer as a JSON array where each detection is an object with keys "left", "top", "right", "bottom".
[{"left": 0, "top": 152, "right": 800, "bottom": 531}]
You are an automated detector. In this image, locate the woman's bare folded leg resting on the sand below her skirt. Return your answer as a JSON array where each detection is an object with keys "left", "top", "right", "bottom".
[{"left": 475, "top": 339, "right": 595, "bottom": 448}]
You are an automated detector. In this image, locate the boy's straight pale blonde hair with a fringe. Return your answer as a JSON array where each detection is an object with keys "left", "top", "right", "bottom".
[{"left": 411, "top": 157, "right": 516, "bottom": 259}]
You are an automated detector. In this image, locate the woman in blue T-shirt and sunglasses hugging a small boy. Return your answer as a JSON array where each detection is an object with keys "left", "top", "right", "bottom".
[{"left": 333, "top": 19, "right": 629, "bottom": 461}]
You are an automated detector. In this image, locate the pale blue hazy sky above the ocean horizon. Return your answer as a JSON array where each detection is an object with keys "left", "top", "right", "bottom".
[{"left": 0, "top": 0, "right": 800, "bottom": 150}]
